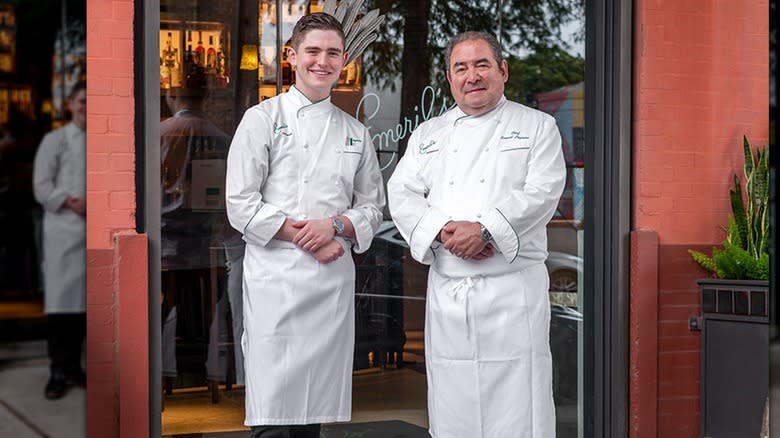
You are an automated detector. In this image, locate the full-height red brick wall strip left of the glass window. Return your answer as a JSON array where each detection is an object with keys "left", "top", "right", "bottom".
[{"left": 87, "top": 0, "right": 149, "bottom": 438}]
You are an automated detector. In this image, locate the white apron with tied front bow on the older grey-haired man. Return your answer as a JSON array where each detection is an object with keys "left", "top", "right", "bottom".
[{"left": 425, "top": 264, "right": 555, "bottom": 438}]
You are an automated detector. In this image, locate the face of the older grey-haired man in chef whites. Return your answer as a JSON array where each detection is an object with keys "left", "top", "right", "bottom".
[{"left": 447, "top": 39, "right": 509, "bottom": 116}]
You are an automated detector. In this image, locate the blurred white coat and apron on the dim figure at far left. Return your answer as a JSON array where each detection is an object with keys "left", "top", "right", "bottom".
[{"left": 33, "top": 123, "right": 87, "bottom": 313}]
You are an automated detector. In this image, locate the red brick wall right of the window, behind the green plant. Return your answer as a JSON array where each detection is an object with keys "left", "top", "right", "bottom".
[{"left": 630, "top": 0, "right": 769, "bottom": 438}]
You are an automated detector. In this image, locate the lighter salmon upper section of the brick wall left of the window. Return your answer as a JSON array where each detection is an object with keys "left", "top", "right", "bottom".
[{"left": 87, "top": 0, "right": 135, "bottom": 248}]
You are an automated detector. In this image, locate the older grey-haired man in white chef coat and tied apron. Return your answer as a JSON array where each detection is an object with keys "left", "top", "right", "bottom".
[{"left": 387, "top": 32, "right": 566, "bottom": 438}]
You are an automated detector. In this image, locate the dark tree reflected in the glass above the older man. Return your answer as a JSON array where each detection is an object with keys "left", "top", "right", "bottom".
[{"left": 364, "top": 0, "right": 585, "bottom": 155}]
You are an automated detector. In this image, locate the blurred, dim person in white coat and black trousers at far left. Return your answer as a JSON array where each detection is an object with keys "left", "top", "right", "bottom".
[{"left": 33, "top": 82, "right": 87, "bottom": 400}]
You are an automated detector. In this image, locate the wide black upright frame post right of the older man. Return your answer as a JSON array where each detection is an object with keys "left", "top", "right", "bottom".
[{"left": 582, "top": 0, "right": 633, "bottom": 437}]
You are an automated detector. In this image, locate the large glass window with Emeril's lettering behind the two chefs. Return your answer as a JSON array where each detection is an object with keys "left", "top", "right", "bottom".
[{"left": 159, "top": 0, "right": 585, "bottom": 437}]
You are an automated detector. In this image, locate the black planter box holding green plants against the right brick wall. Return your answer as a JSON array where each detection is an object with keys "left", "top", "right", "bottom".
[{"left": 698, "top": 279, "right": 769, "bottom": 438}]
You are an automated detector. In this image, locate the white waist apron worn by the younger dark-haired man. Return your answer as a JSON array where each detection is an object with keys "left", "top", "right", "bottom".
[{"left": 242, "top": 242, "right": 355, "bottom": 425}]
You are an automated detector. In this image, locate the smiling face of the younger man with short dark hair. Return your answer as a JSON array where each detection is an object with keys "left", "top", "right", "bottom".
[{"left": 287, "top": 29, "right": 347, "bottom": 102}]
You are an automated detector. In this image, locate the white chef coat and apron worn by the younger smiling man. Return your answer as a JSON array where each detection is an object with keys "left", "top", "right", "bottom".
[{"left": 226, "top": 86, "right": 385, "bottom": 426}]
